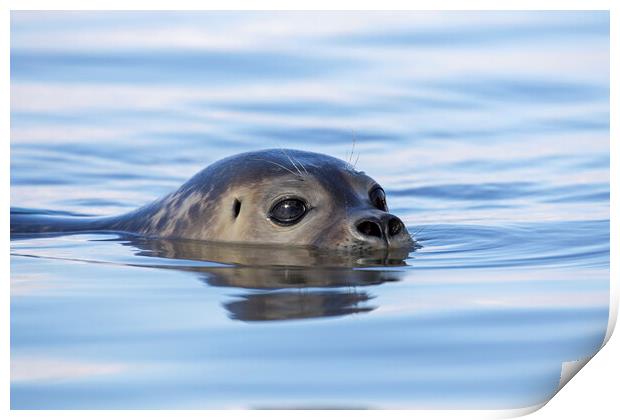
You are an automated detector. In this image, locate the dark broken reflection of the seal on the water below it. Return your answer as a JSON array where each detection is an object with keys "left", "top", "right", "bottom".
[{"left": 125, "top": 237, "right": 409, "bottom": 321}]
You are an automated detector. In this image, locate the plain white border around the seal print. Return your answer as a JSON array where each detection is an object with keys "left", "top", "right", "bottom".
[{"left": 0, "top": 0, "right": 620, "bottom": 420}]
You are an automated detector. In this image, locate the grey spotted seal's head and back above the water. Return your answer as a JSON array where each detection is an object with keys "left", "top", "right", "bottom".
[{"left": 11, "top": 149, "right": 414, "bottom": 251}]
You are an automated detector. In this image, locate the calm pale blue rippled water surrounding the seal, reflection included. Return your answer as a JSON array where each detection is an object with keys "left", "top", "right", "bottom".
[{"left": 11, "top": 12, "right": 609, "bottom": 408}]
